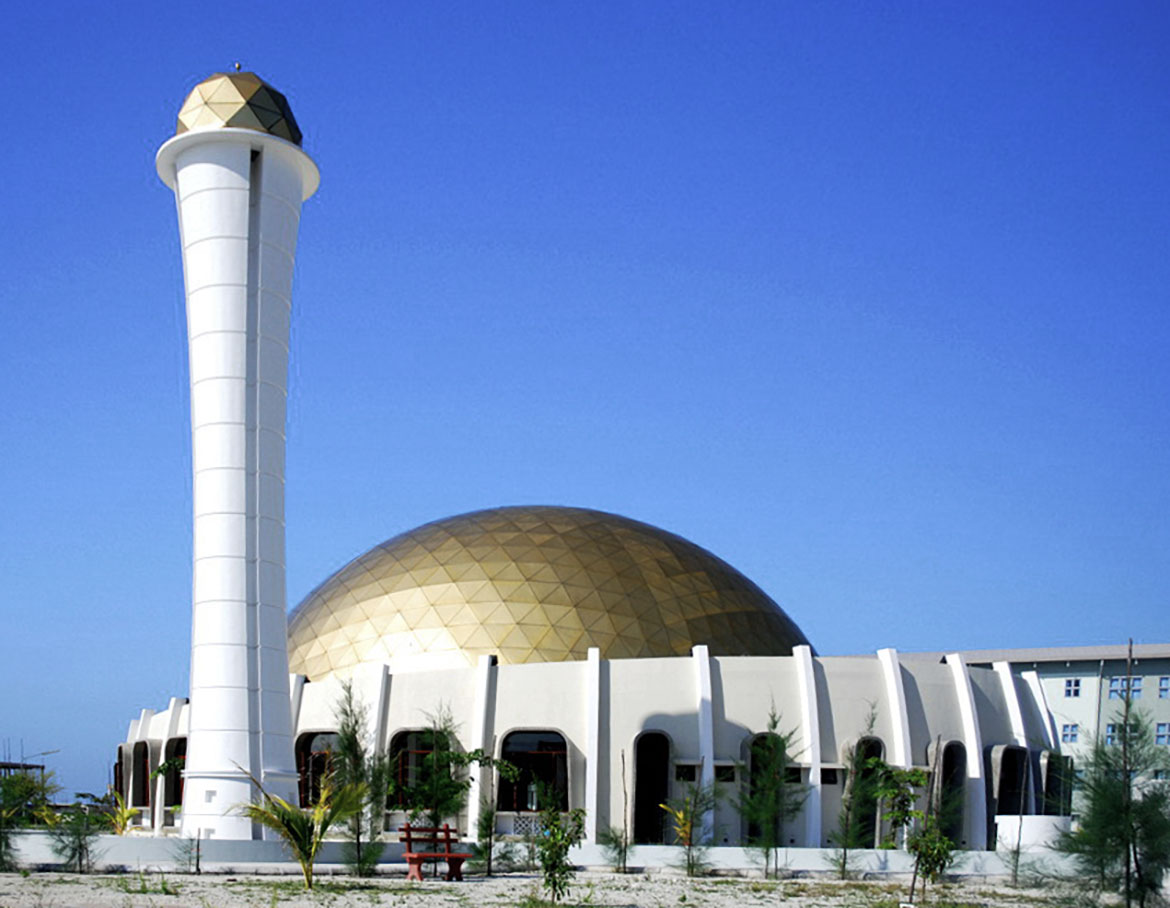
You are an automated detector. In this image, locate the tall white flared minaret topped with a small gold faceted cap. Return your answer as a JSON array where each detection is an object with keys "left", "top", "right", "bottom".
[{"left": 157, "top": 71, "right": 319, "bottom": 839}]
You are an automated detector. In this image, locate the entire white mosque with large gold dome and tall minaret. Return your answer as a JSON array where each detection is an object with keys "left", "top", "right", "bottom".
[{"left": 115, "top": 71, "right": 1069, "bottom": 849}]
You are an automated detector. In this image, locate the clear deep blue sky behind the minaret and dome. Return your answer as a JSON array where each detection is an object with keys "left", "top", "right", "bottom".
[{"left": 0, "top": 0, "right": 1170, "bottom": 790}]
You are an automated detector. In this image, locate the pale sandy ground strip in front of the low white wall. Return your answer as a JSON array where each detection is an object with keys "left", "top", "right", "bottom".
[{"left": 0, "top": 872, "right": 1085, "bottom": 908}]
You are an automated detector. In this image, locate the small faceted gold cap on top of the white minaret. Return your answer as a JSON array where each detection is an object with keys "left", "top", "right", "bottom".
[{"left": 174, "top": 73, "right": 301, "bottom": 145}]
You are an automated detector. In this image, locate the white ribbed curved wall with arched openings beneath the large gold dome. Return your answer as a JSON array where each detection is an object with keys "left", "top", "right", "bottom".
[{"left": 119, "top": 631, "right": 1069, "bottom": 849}]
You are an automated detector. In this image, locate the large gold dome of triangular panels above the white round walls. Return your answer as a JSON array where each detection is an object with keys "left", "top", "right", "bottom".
[{"left": 289, "top": 507, "right": 807, "bottom": 680}]
